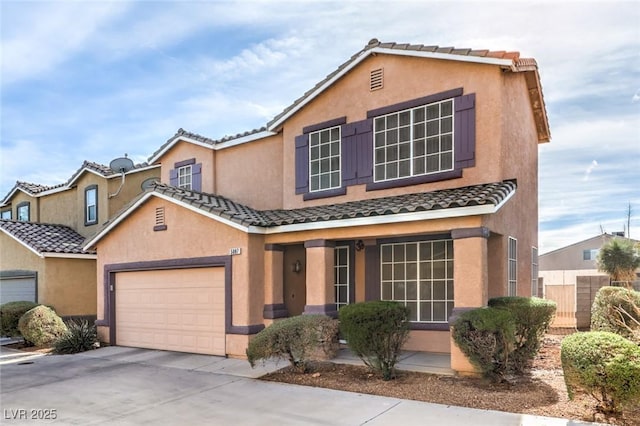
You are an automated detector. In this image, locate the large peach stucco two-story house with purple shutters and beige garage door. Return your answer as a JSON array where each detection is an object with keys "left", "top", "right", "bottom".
[{"left": 85, "top": 39, "right": 550, "bottom": 371}]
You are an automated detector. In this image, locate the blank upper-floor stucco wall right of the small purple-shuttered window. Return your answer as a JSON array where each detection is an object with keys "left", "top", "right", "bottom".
[{"left": 214, "top": 134, "right": 282, "bottom": 210}]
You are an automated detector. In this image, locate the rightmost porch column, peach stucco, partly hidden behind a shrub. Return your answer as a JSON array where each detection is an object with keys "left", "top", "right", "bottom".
[{"left": 449, "top": 227, "right": 490, "bottom": 375}]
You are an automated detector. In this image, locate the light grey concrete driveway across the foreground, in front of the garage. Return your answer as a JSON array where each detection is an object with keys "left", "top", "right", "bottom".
[{"left": 0, "top": 347, "right": 600, "bottom": 426}]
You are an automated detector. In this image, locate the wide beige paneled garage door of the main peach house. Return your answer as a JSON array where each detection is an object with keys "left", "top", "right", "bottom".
[{"left": 115, "top": 268, "right": 225, "bottom": 355}]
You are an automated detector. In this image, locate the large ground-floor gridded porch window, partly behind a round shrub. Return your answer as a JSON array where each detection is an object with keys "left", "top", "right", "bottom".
[{"left": 380, "top": 240, "right": 453, "bottom": 323}]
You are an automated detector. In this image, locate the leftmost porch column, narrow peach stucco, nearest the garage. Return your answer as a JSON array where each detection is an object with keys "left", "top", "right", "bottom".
[{"left": 263, "top": 244, "right": 289, "bottom": 320}]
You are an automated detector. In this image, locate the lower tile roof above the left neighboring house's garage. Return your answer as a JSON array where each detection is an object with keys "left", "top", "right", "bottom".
[{"left": 0, "top": 219, "right": 96, "bottom": 254}]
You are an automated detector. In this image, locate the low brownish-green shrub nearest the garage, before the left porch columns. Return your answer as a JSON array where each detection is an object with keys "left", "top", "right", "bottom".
[{"left": 246, "top": 315, "right": 338, "bottom": 371}]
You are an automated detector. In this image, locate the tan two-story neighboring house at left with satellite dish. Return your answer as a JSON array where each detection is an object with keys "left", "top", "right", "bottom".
[{"left": 0, "top": 161, "right": 159, "bottom": 317}]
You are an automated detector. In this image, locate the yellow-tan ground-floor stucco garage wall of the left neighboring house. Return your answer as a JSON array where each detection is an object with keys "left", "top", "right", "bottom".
[{"left": 0, "top": 232, "right": 96, "bottom": 316}]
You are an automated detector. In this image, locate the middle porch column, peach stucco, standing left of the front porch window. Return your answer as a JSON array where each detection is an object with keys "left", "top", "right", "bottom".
[{"left": 304, "top": 240, "right": 338, "bottom": 318}]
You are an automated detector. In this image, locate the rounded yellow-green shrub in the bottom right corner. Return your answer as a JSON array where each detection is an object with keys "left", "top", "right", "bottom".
[{"left": 560, "top": 331, "right": 640, "bottom": 412}]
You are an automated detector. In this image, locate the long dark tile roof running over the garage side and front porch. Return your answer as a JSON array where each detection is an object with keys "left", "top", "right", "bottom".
[{"left": 153, "top": 180, "right": 516, "bottom": 228}]
